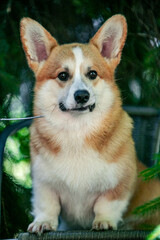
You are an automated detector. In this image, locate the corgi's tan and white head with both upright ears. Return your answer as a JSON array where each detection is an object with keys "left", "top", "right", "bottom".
[{"left": 21, "top": 15, "right": 127, "bottom": 119}]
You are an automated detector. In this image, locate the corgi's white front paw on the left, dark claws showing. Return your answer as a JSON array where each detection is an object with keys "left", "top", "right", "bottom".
[{"left": 27, "top": 221, "right": 58, "bottom": 235}]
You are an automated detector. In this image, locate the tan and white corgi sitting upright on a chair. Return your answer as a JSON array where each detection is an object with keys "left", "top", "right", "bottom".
[{"left": 20, "top": 15, "right": 160, "bottom": 233}]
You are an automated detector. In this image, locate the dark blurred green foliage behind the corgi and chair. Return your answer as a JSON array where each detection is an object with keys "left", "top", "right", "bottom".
[{"left": 0, "top": 0, "right": 160, "bottom": 238}]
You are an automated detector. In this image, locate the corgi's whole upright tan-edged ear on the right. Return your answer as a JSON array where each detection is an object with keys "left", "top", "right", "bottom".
[{"left": 90, "top": 14, "right": 127, "bottom": 67}]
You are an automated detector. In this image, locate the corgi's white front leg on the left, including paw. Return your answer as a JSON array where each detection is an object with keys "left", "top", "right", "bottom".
[{"left": 28, "top": 181, "right": 60, "bottom": 234}]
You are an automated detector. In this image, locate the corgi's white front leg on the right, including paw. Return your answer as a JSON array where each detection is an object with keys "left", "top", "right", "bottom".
[{"left": 92, "top": 193, "right": 130, "bottom": 230}]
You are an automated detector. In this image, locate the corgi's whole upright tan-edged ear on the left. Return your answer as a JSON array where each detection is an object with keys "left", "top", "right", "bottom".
[{"left": 20, "top": 18, "right": 58, "bottom": 73}]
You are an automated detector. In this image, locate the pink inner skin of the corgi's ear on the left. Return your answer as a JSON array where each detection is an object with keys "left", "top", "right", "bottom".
[{"left": 32, "top": 34, "right": 48, "bottom": 62}]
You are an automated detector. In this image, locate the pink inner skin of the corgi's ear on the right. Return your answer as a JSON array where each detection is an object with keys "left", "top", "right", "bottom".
[{"left": 101, "top": 36, "right": 114, "bottom": 58}]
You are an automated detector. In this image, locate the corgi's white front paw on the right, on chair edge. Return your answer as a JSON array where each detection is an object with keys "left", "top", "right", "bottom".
[{"left": 92, "top": 220, "right": 117, "bottom": 231}]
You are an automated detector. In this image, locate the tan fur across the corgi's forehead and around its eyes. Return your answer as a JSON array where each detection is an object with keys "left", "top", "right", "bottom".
[{"left": 36, "top": 43, "right": 114, "bottom": 89}]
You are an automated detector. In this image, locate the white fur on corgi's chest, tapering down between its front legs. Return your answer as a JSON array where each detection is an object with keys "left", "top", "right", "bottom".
[{"left": 32, "top": 127, "right": 121, "bottom": 227}]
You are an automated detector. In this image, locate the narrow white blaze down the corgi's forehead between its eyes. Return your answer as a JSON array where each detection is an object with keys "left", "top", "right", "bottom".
[{"left": 72, "top": 47, "right": 84, "bottom": 82}]
